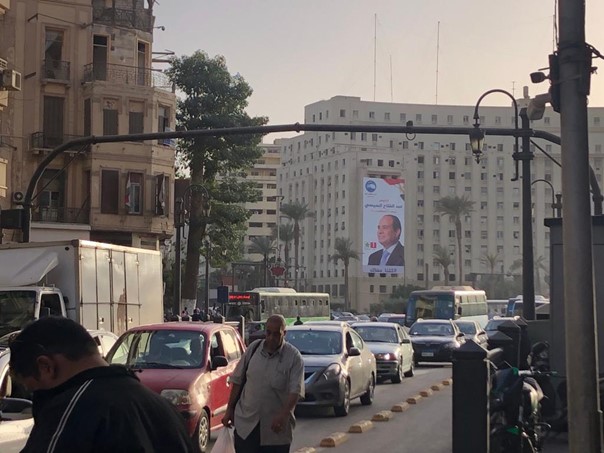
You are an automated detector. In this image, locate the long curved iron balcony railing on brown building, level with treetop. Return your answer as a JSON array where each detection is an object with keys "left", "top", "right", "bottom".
[{"left": 83, "top": 63, "right": 173, "bottom": 91}]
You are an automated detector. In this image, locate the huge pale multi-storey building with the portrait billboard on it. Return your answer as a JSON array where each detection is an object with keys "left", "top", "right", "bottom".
[{"left": 276, "top": 96, "right": 604, "bottom": 310}]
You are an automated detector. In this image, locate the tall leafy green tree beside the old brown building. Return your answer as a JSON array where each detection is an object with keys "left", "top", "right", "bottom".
[{"left": 168, "top": 51, "right": 267, "bottom": 306}]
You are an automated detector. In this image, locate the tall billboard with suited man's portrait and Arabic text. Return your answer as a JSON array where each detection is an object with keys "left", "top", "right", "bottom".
[{"left": 362, "top": 178, "right": 405, "bottom": 274}]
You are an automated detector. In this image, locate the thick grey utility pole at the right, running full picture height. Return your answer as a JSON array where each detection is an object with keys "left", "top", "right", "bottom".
[{"left": 550, "top": 0, "right": 602, "bottom": 453}]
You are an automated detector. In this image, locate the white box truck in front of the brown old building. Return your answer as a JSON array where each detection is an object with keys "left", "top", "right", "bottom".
[{"left": 0, "top": 240, "right": 163, "bottom": 337}]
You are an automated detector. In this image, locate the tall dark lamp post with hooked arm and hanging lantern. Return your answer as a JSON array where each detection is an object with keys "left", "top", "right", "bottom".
[{"left": 470, "top": 89, "right": 535, "bottom": 320}]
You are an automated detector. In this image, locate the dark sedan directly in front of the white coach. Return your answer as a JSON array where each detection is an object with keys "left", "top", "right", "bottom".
[{"left": 409, "top": 319, "right": 466, "bottom": 365}]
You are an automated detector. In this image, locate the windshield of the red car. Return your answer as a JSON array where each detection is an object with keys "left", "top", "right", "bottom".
[{"left": 107, "top": 330, "right": 206, "bottom": 369}]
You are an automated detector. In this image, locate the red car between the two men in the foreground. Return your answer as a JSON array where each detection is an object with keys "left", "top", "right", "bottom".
[{"left": 107, "top": 322, "right": 245, "bottom": 452}]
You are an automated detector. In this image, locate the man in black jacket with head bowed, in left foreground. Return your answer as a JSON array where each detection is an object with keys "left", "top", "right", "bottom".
[{"left": 10, "top": 317, "right": 195, "bottom": 453}]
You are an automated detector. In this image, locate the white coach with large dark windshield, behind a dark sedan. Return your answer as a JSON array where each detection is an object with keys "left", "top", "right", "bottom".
[{"left": 405, "top": 286, "right": 488, "bottom": 327}]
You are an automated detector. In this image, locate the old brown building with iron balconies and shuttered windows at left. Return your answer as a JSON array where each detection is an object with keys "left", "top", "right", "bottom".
[{"left": 0, "top": 0, "right": 176, "bottom": 249}]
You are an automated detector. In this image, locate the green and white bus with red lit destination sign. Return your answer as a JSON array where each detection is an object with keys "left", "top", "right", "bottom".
[{"left": 225, "top": 288, "right": 331, "bottom": 325}]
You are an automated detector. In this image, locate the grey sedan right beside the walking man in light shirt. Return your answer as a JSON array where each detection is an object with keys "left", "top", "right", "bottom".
[{"left": 285, "top": 323, "right": 377, "bottom": 417}]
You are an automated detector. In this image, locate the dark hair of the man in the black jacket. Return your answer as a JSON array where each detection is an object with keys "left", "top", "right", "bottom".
[{"left": 10, "top": 316, "right": 99, "bottom": 377}]
